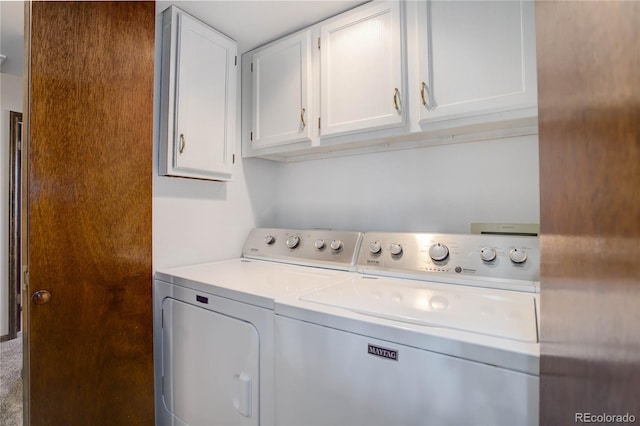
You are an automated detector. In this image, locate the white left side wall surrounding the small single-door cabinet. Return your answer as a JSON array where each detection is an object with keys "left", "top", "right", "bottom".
[{"left": 153, "top": 8, "right": 277, "bottom": 270}]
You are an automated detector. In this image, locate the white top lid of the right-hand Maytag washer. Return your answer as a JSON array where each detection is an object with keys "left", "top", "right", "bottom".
[{"left": 300, "top": 276, "right": 538, "bottom": 343}]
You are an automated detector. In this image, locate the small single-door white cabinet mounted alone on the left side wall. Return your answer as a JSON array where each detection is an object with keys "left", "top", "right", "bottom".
[{"left": 159, "top": 6, "right": 237, "bottom": 180}]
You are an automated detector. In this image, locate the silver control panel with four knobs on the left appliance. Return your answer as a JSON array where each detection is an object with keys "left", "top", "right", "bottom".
[{"left": 242, "top": 228, "right": 363, "bottom": 270}]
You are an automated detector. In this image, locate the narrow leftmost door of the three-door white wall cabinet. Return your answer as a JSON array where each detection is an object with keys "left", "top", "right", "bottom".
[{"left": 251, "top": 30, "right": 312, "bottom": 149}]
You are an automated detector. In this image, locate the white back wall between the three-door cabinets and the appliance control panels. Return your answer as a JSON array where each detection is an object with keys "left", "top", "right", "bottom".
[{"left": 273, "top": 136, "right": 540, "bottom": 233}]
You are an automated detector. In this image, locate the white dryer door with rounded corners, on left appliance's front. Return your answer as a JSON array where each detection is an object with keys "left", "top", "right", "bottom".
[{"left": 162, "top": 298, "right": 260, "bottom": 426}]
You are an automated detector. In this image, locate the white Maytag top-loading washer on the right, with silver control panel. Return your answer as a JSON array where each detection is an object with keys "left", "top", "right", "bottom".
[{"left": 275, "top": 233, "right": 539, "bottom": 426}]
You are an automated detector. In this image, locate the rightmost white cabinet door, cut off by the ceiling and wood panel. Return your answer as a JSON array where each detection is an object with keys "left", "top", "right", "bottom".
[{"left": 416, "top": 1, "right": 537, "bottom": 122}]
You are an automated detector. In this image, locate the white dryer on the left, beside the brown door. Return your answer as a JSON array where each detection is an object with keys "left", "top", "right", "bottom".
[{"left": 153, "top": 229, "right": 362, "bottom": 426}]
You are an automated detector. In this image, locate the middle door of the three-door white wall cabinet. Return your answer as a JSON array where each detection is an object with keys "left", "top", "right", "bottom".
[{"left": 320, "top": 1, "right": 405, "bottom": 136}]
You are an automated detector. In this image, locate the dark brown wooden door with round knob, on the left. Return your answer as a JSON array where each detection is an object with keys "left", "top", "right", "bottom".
[{"left": 25, "top": 2, "right": 155, "bottom": 426}]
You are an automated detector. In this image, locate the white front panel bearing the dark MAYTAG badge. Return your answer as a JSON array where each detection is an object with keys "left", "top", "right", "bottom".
[{"left": 275, "top": 315, "right": 539, "bottom": 426}]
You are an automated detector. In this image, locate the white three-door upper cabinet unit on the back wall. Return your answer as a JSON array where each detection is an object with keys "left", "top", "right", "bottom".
[{"left": 242, "top": 0, "right": 538, "bottom": 161}]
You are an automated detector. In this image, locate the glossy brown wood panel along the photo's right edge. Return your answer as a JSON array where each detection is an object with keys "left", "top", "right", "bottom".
[{"left": 536, "top": 1, "right": 640, "bottom": 425}]
